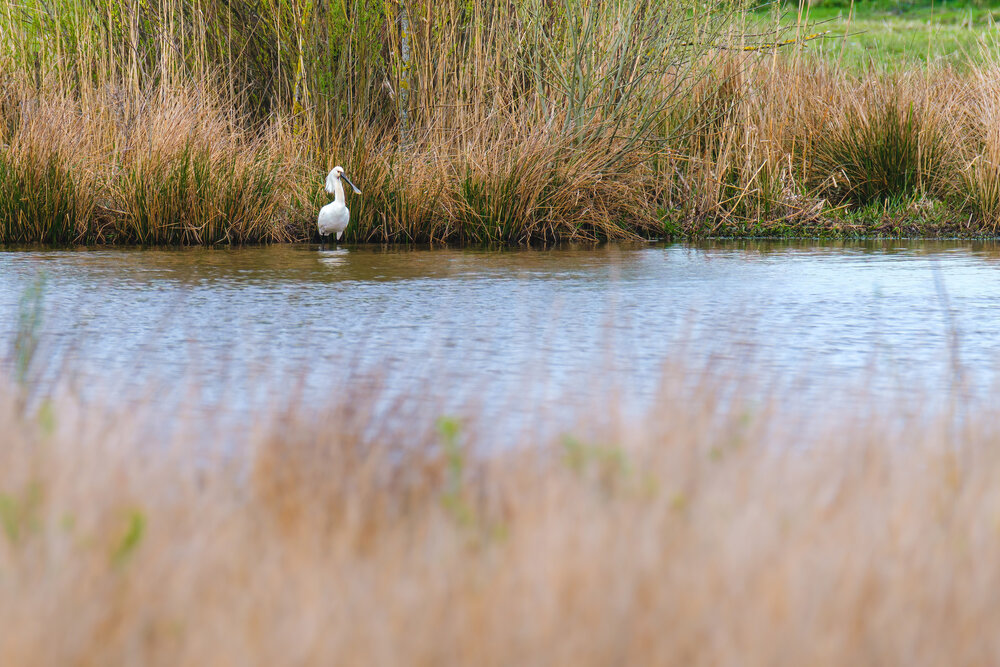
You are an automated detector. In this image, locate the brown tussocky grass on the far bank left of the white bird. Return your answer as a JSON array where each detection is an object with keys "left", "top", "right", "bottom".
[{"left": 0, "top": 78, "right": 300, "bottom": 245}]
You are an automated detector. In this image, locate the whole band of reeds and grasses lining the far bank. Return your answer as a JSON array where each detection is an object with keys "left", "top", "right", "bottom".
[{"left": 0, "top": 0, "right": 1000, "bottom": 245}]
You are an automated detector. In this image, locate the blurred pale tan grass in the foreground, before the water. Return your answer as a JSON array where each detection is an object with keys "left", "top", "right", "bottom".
[{"left": 0, "top": 362, "right": 1000, "bottom": 664}]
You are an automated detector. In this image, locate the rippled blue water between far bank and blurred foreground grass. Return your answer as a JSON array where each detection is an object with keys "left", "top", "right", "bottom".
[{"left": 0, "top": 242, "right": 1000, "bottom": 430}]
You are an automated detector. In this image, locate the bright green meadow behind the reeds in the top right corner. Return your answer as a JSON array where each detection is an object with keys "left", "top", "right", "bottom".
[{"left": 756, "top": 0, "right": 1000, "bottom": 69}]
